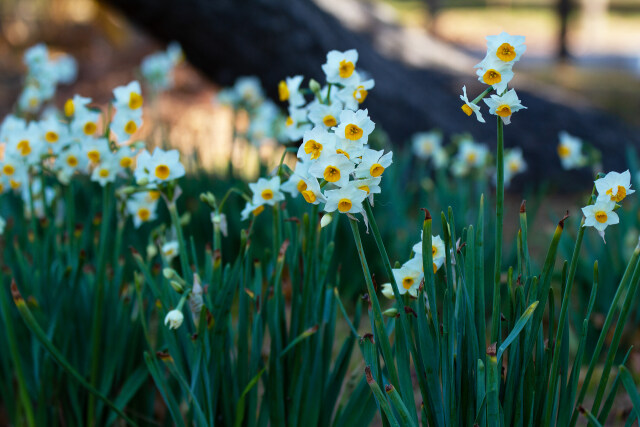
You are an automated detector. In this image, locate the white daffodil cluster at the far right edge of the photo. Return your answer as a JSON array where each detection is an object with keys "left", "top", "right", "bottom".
[{"left": 582, "top": 170, "right": 635, "bottom": 244}]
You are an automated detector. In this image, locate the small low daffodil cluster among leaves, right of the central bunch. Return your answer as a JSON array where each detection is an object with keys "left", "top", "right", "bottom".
[{"left": 382, "top": 235, "right": 445, "bottom": 299}]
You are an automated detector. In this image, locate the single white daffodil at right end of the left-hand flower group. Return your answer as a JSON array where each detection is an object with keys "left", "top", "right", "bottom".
[{"left": 134, "top": 147, "right": 185, "bottom": 183}]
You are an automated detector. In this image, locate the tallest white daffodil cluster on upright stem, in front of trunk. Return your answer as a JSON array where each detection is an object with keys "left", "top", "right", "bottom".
[{"left": 460, "top": 32, "right": 527, "bottom": 125}]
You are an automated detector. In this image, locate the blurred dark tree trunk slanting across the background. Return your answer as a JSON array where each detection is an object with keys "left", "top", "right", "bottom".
[{"left": 102, "top": 0, "right": 639, "bottom": 188}]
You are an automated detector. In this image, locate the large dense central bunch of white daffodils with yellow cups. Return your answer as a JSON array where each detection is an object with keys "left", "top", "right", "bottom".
[{"left": 243, "top": 50, "right": 393, "bottom": 219}]
